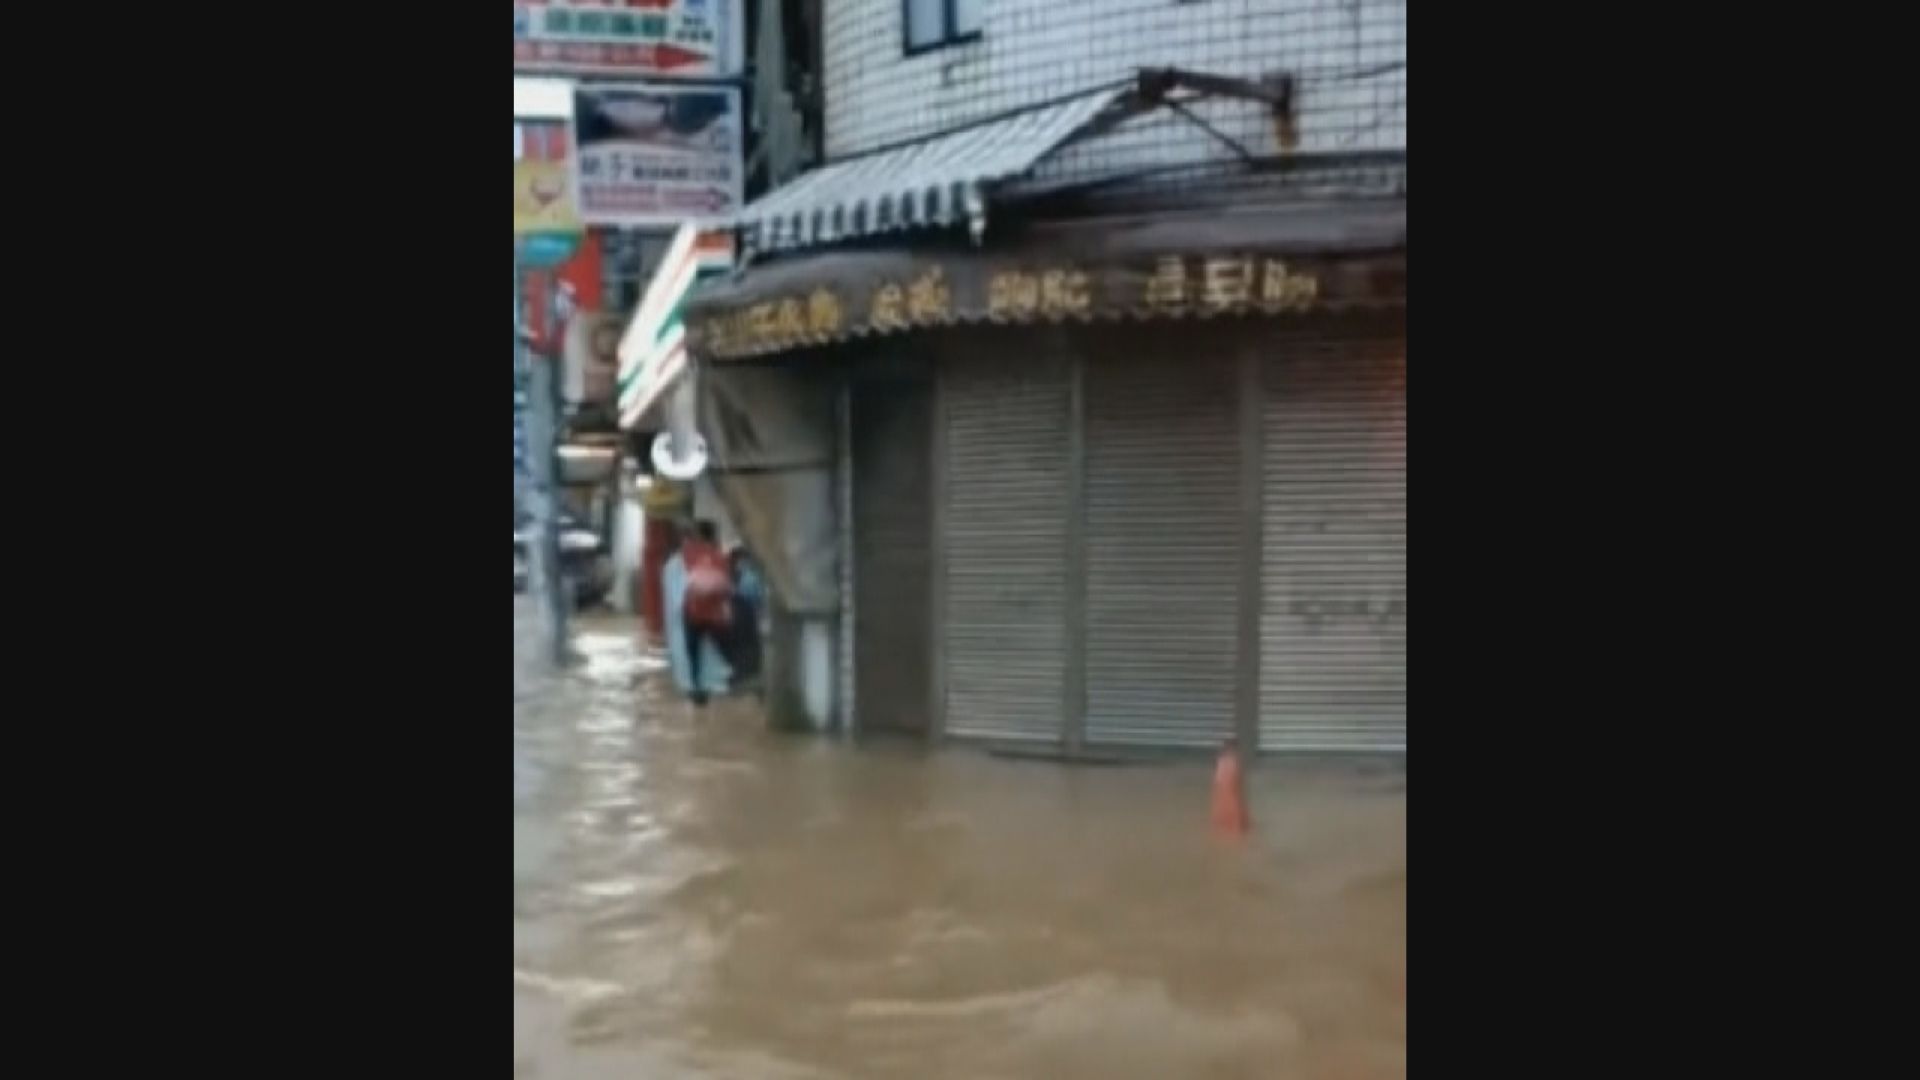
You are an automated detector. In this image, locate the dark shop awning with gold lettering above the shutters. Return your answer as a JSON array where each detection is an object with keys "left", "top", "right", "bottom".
[{"left": 687, "top": 200, "right": 1407, "bottom": 359}]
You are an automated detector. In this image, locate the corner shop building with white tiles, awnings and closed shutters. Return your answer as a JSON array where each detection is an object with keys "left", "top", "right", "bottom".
[{"left": 687, "top": 0, "right": 1405, "bottom": 755}]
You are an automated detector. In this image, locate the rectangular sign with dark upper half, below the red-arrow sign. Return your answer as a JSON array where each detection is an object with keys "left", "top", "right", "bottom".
[{"left": 574, "top": 85, "right": 745, "bottom": 229}]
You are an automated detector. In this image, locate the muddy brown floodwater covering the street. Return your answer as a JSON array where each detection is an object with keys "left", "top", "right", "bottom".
[{"left": 513, "top": 601, "right": 1407, "bottom": 1080}]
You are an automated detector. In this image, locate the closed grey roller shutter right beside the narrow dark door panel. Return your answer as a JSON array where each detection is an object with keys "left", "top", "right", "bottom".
[{"left": 941, "top": 353, "right": 1068, "bottom": 742}]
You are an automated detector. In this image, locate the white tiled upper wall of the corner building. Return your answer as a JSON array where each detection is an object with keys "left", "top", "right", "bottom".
[{"left": 824, "top": 0, "right": 1407, "bottom": 179}]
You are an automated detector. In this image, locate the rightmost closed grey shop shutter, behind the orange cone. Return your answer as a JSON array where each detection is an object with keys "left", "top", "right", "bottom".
[{"left": 1260, "top": 331, "right": 1407, "bottom": 751}]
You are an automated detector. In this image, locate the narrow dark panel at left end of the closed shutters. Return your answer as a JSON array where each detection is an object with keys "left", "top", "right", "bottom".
[{"left": 851, "top": 382, "right": 933, "bottom": 732}]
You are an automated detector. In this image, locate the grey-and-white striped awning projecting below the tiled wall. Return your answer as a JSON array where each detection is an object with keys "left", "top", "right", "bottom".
[{"left": 732, "top": 83, "right": 1133, "bottom": 252}]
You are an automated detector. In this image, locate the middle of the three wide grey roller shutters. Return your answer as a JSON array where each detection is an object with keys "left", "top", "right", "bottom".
[{"left": 1087, "top": 332, "right": 1240, "bottom": 746}]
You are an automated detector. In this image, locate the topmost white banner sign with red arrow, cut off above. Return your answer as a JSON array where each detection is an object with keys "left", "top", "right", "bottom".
[{"left": 513, "top": 0, "right": 747, "bottom": 79}]
